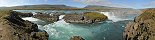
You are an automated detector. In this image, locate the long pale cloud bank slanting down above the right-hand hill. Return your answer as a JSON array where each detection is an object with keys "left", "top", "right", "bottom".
[{"left": 73, "top": 0, "right": 132, "bottom": 7}]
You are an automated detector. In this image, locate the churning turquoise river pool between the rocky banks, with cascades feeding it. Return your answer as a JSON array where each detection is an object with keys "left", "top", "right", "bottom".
[{"left": 18, "top": 9, "right": 139, "bottom": 40}]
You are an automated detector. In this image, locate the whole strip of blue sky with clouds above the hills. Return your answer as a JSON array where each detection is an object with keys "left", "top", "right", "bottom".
[{"left": 0, "top": 0, "right": 155, "bottom": 9}]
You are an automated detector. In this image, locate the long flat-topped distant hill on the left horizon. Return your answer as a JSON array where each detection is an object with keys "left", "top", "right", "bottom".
[{"left": 0, "top": 4, "right": 78, "bottom": 9}]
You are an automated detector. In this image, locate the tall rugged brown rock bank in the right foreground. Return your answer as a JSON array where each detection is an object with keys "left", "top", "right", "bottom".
[{"left": 124, "top": 9, "right": 155, "bottom": 40}]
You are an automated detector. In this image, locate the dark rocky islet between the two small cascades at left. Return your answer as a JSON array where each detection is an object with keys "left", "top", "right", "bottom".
[{"left": 33, "top": 13, "right": 59, "bottom": 22}]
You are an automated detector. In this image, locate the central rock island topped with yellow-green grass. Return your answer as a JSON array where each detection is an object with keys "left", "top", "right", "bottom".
[{"left": 63, "top": 12, "right": 107, "bottom": 24}]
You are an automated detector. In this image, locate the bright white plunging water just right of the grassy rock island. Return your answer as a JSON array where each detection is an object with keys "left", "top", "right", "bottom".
[{"left": 100, "top": 12, "right": 129, "bottom": 22}]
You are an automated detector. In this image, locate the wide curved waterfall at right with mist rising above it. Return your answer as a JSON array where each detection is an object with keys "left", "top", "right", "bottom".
[{"left": 100, "top": 9, "right": 141, "bottom": 22}]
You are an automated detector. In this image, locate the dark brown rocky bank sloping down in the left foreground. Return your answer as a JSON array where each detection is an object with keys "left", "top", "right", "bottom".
[{"left": 0, "top": 10, "right": 48, "bottom": 40}]
